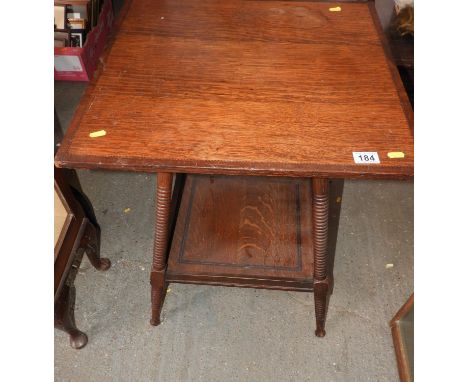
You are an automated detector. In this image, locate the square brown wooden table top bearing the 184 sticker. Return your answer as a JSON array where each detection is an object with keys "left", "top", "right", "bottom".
[{"left": 55, "top": 0, "right": 413, "bottom": 179}]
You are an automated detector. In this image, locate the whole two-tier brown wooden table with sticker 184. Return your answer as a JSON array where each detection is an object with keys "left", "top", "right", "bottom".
[{"left": 55, "top": 0, "right": 413, "bottom": 337}]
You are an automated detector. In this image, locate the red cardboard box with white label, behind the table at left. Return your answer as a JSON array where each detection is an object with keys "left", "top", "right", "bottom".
[{"left": 54, "top": 0, "right": 114, "bottom": 81}]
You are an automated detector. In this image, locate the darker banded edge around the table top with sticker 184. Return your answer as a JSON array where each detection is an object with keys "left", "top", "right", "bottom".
[{"left": 54, "top": 0, "right": 414, "bottom": 180}]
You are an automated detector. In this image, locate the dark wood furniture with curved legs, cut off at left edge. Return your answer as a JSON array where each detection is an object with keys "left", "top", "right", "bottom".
[{"left": 54, "top": 113, "right": 110, "bottom": 349}]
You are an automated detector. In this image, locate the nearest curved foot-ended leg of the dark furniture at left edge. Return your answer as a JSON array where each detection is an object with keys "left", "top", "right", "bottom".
[{"left": 54, "top": 284, "right": 88, "bottom": 349}]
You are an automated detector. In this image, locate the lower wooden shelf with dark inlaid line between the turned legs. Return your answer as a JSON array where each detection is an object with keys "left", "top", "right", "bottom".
[{"left": 166, "top": 175, "right": 313, "bottom": 291}]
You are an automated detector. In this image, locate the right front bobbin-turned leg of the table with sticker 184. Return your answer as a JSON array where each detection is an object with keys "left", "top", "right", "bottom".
[{"left": 312, "top": 178, "right": 330, "bottom": 337}]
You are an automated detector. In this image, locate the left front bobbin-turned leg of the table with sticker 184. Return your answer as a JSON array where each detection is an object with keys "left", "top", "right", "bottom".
[{"left": 150, "top": 173, "right": 172, "bottom": 326}]
